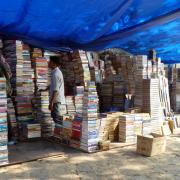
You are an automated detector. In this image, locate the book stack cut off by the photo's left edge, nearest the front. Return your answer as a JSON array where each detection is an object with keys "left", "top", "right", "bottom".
[{"left": 0, "top": 78, "right": 8, "bottom": 165}]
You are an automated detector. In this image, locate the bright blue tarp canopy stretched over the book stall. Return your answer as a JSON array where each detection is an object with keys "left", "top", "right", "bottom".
[{"left": 0, "top": 0, "right": 180, "bottom": 63}]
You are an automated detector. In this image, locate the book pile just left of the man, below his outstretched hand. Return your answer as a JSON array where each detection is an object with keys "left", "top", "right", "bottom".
[{"left": 36, "top": 91, "right": 54, "bottom": 137}]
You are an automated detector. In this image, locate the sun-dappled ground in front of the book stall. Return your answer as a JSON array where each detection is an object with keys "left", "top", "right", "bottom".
[{"left": 0, "top": 135, "right": 180, "bottom": 180}]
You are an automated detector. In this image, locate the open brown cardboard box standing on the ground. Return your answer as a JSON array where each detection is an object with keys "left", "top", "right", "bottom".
[{"left": 136, "top": 133, "right": 166, "bottom": 156}]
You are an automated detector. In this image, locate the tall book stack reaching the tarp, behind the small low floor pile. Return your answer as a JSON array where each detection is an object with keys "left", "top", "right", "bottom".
[{"left": 15, "top": 41, "right": 34, "bottom": 128}]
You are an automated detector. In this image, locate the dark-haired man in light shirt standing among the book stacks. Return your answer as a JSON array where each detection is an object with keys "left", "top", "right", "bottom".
[{"left": 49, "top": 56, "right": 66, "bottom": 123}]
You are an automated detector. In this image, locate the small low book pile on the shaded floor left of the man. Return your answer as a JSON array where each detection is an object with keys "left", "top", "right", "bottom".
[{"left": 23, "top": 123, "right": 41, "bottom": 139}]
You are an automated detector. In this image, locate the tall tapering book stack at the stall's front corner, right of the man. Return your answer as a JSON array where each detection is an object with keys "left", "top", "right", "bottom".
[{"left": 80, "top": 82, "right": 98, "bottom": 152}]
